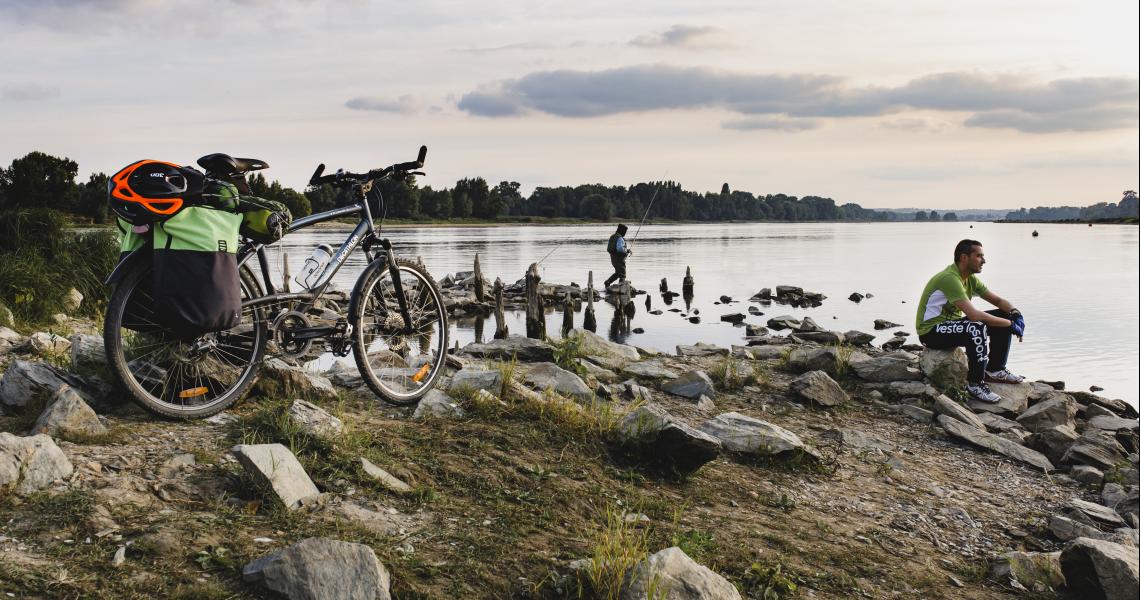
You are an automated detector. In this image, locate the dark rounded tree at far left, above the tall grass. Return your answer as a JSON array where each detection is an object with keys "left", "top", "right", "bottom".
[{"left": 0, "top": 152, "right": 79, "bottom": 211}]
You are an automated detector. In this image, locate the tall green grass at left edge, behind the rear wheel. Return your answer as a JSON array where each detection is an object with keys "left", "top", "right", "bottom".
[{"left": 0, "top": 209, "right": 119, "bottom": 324}]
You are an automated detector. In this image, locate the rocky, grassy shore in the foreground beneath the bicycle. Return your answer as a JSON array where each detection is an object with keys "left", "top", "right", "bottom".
[{"left": 0, "top": 298, "right": 1140, "bottom": 599}]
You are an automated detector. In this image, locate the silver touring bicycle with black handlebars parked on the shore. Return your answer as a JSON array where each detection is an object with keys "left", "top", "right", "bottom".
[{"left": 104, "top": 146, "right": 448, "bottom": 419}]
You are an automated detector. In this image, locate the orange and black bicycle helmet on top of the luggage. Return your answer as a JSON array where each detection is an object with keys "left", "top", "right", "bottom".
[{"left": 107, "top": 160, "right": 205, "bottom": 225}]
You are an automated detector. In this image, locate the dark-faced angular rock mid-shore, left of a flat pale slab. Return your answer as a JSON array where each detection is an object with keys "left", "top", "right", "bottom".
[{"left": 618, "top": 404, "right": 720, "bottom": 473}]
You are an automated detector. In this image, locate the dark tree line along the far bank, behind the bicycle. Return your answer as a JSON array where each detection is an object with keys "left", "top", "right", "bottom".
[{"left": 0, "top": 152, "right": 896, "bottom": 222}]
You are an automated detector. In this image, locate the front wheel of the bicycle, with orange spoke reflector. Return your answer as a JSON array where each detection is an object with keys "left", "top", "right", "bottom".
[{"left": 349, "top": 259, "right": 447, "bottom": 406}]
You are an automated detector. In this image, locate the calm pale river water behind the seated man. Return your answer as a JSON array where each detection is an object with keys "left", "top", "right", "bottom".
[{"left": 275, "top": 222, "right": 1140, "bottom": 405}]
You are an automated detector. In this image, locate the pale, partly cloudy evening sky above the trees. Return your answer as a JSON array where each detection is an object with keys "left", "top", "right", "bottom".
[{"left": 0, "top": 0, "right": 1140, "bottom": 209}]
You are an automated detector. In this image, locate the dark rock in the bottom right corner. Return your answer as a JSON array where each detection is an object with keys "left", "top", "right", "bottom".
[{"left": 1061, "top": 537, "right": 1140, "bottom": 600}]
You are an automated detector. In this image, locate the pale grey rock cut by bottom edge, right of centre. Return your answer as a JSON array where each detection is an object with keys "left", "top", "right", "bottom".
[{"left": 621, "top": 546, "right": 741, "bottom": 600}]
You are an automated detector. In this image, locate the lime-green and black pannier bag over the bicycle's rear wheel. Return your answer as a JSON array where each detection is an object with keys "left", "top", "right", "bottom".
[{"left": 152, "top": 206, "right": 242, "bottom": 338}]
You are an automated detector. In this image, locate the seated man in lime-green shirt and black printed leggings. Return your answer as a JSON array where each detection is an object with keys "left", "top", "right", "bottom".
[{"left": 914, "top": 240, "right": 1025, "bottom": 403}]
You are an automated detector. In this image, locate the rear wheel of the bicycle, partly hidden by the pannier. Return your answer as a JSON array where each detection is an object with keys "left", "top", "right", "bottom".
[{"left": 103, "top": 260, "right": 269, "bottom": 420}]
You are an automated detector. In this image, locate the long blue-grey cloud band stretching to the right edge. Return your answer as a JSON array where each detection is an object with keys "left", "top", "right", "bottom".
[{"left": 459, "top": 65, "right": 1138, "bottom": 133}]
